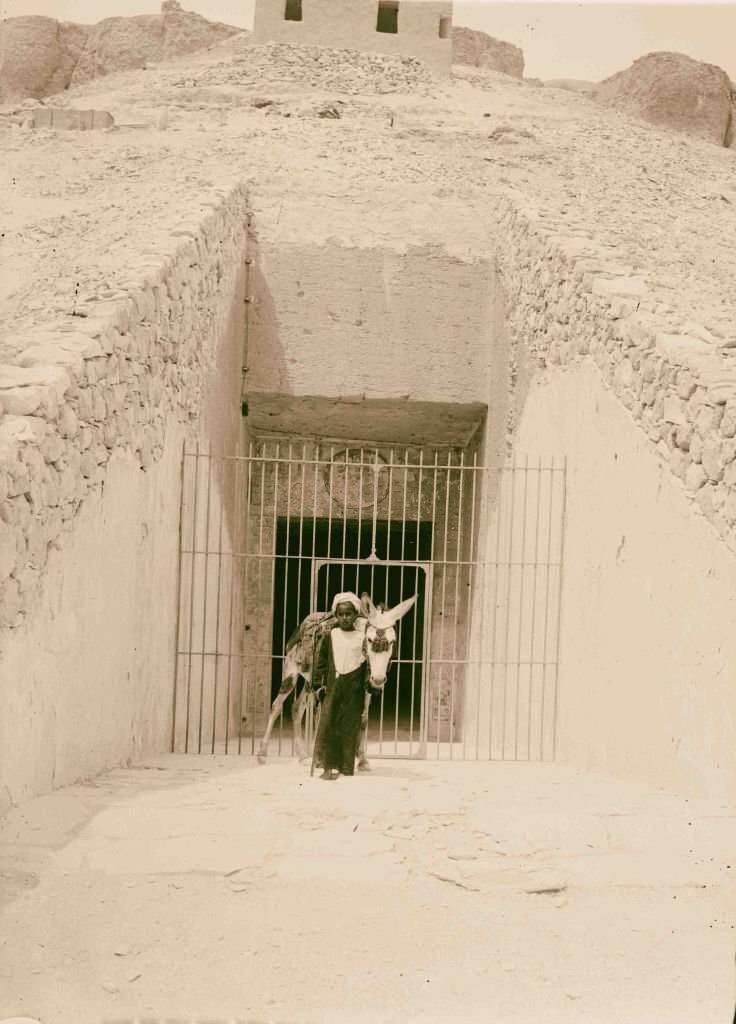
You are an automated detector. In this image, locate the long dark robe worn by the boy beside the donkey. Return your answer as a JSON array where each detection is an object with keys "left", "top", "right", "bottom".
[{"left": 312, "top": 632, "right": 370, "bottom": 775}]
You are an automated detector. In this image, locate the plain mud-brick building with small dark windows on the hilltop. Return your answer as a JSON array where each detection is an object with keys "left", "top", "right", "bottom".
[{"left": 254, "top": 0, "right": 452, "bottom": 74}]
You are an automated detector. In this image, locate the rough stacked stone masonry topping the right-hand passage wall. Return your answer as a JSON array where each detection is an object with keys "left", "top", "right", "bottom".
[{"left": 495, "top": 197, "right": 736, "bottom": 550}]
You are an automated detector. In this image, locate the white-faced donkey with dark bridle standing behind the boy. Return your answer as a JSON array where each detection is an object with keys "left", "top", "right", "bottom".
[{"left": 258, "top": 594, "right": 417, "bottom": 771}]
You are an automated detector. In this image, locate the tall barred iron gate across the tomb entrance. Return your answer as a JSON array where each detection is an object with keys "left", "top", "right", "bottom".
[{"left": 172, "top": 440, "right": 566, "bottom": 761}]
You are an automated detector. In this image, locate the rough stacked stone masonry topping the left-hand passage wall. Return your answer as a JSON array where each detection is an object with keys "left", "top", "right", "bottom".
[{"left": 0, "top": 185, "right": 247, "bottom": 628}]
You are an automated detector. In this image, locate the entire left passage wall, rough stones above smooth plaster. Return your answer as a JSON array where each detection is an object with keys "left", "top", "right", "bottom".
[{"left": 0, "top": 186, "right": 248, "bottom": 809}]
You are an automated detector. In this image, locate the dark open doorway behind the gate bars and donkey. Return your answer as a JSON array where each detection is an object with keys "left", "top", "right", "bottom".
[{"left": 271, "top": 518, "right": 432, "bottom": 743}]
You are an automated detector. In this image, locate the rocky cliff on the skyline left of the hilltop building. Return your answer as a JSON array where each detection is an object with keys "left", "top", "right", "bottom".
[{"left": 0, "top": 0, "right": 243, "bottom": 103}]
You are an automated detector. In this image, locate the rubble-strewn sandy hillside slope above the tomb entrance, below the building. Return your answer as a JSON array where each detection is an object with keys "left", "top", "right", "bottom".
[{"left": 0, "top": 37, "right": 736, "bottom": 358}]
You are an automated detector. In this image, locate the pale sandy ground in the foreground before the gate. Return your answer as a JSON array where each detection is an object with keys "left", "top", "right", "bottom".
[{"left": 0, "top": 756, "right": 736, "bottom": 1024}]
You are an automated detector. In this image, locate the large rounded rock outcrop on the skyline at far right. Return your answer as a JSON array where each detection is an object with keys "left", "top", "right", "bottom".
[{"left": 594, "top": 52, "right": 736, "bottom": 145}]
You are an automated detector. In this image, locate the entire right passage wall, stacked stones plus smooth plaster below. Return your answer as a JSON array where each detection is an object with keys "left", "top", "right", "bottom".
[{"left": 495, "top": 192, "right": 736, "bottom": 800}]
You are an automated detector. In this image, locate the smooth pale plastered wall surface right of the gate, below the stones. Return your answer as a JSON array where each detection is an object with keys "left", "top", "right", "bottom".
[{"left": 517, "top": 365, "right": 736, "bottom": 799}]
